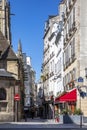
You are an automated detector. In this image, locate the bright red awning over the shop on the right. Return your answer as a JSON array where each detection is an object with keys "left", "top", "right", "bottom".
[{"left": 55, "top": 89, "right": 77, "bottom": 103}]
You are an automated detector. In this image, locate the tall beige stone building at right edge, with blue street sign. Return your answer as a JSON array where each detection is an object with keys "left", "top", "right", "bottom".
[{"left": 62, "top": 0, "right": 87, "bottom": 116}]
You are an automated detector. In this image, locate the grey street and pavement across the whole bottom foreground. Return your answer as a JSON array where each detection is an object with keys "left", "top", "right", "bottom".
[{"left": 0, "top": 118, "right": 87, "bottom": 130}]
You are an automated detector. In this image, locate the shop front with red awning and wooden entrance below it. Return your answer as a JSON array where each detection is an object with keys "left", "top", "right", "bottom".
[{"left": 55, "top": 88, "right": 77, "bottom": 114}]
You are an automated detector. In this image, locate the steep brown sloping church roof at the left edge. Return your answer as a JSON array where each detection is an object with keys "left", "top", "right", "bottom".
[{"left": 0, "top": 31, "right": 18, "bottom": 60}]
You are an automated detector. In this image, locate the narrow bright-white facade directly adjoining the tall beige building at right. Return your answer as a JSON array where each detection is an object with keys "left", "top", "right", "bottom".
[{"left": 54, "top": 21, "right": 64, "bottom": 97}]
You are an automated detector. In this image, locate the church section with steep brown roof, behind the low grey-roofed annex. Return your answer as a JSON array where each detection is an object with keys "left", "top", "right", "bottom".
[{"left": 0, "top": 32, "right": 24, "bottom": 120}]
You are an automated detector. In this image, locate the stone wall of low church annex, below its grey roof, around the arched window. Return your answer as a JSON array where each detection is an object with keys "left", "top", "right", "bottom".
[{"left": 0, "top": 77, "right": 15, "bottom": 122}]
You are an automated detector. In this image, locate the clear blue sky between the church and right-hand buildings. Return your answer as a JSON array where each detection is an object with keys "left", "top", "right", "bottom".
[{"left": 10, "top": 0, "right": 60, "bottom": 80}]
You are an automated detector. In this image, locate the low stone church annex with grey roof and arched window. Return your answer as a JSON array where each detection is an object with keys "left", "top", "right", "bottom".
[{"left": 0, "top": 69, "right": 16, "bottom": 122}]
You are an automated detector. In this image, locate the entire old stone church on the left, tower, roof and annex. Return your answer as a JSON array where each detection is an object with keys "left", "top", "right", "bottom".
[{"left": 0, "top": 0, "right": 24, "bottom": 122}]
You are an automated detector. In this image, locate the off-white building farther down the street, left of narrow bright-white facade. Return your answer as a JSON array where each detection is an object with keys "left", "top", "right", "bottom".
[{"left": 43, "top": 16, "right": 59, "bottom": 100}]
